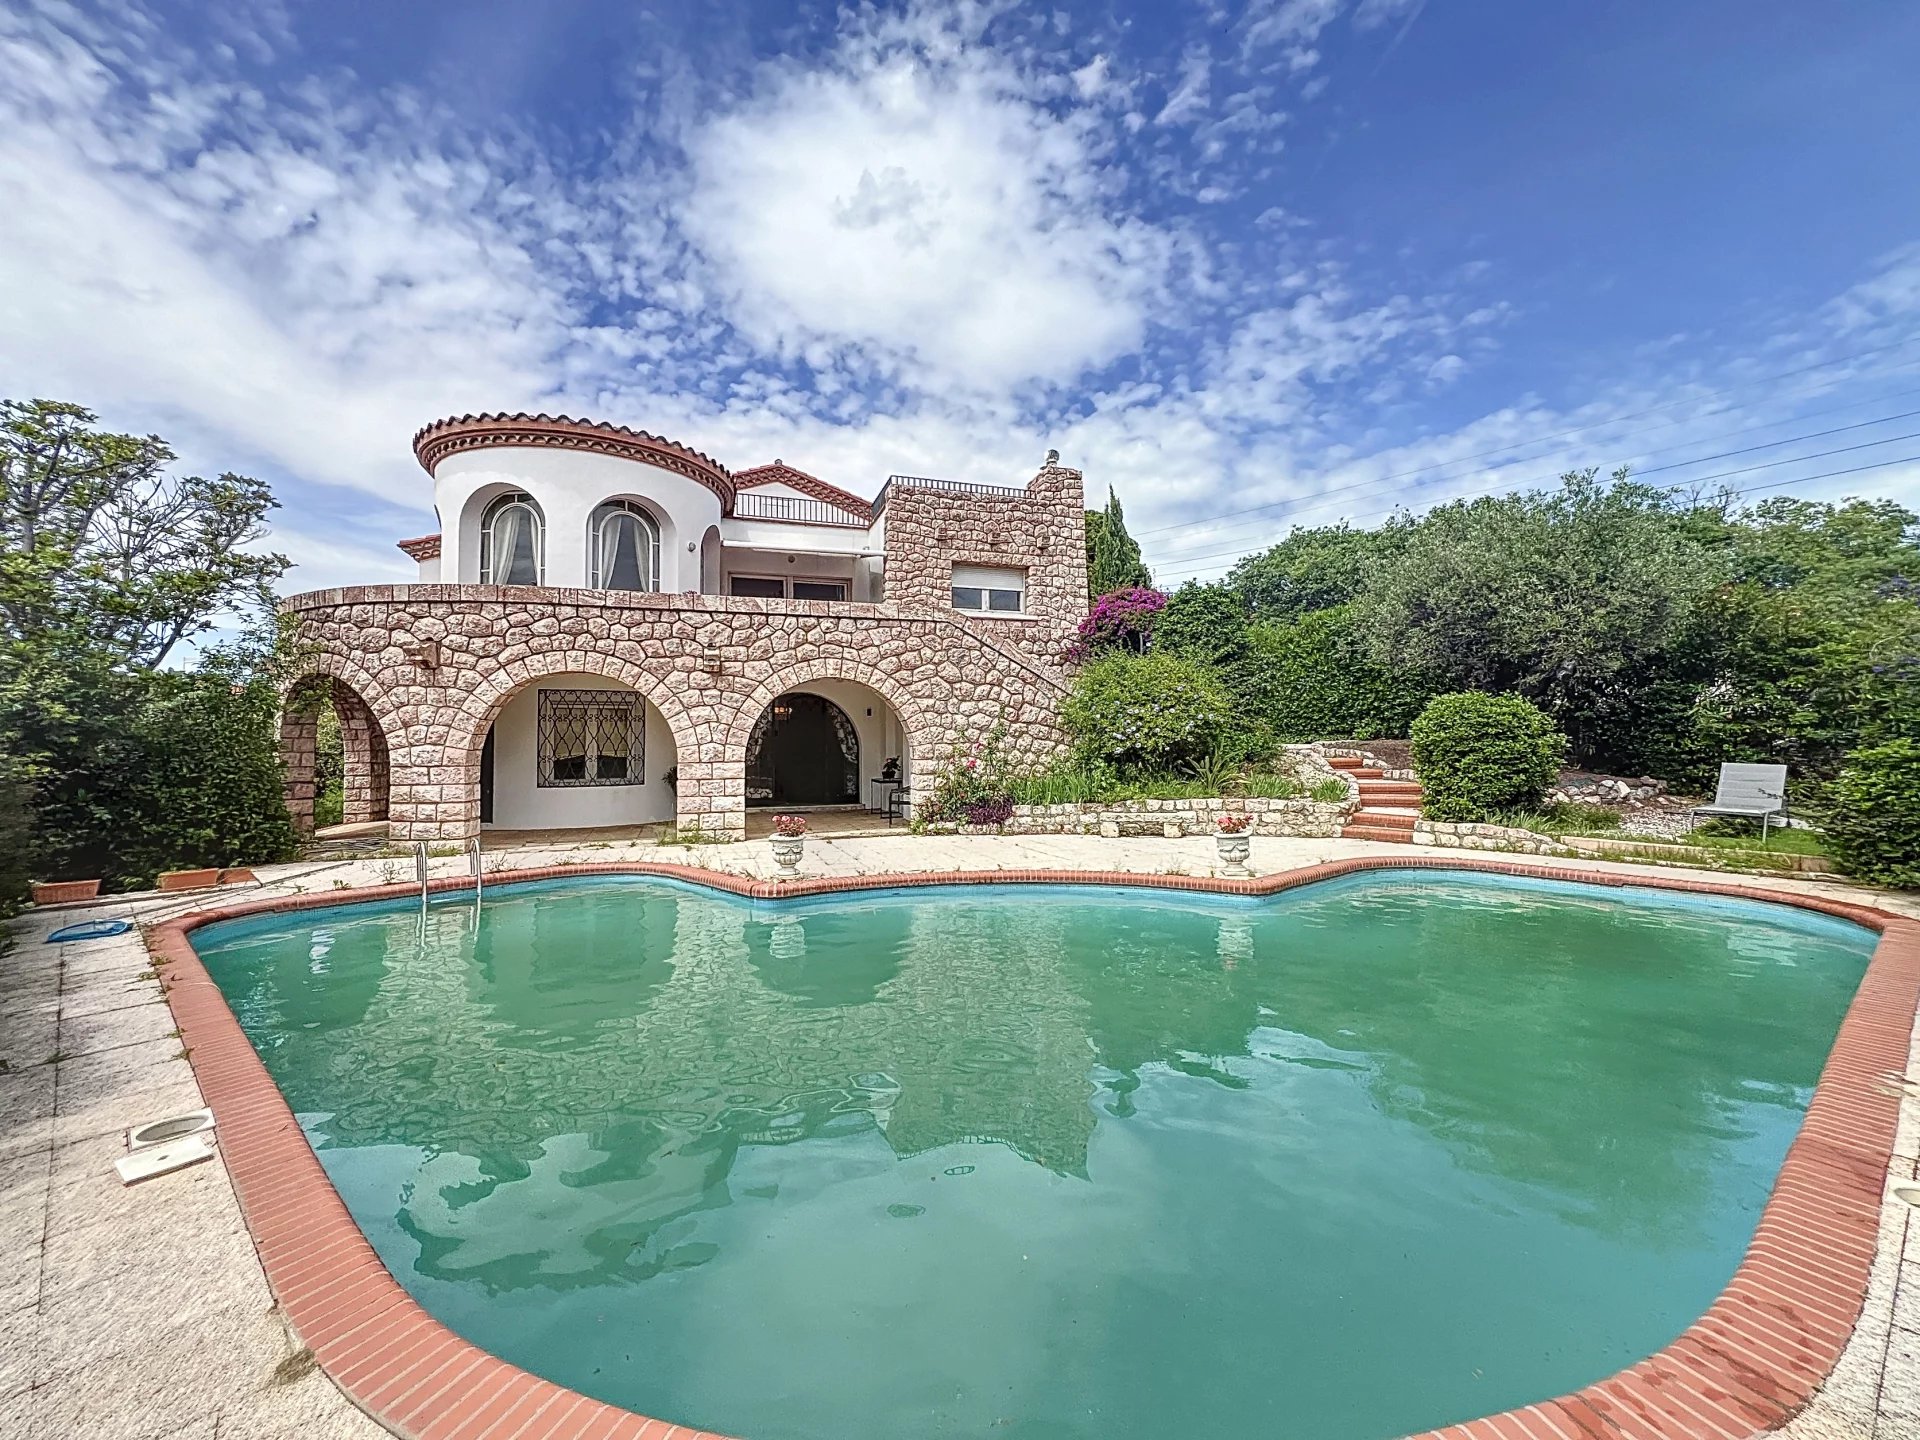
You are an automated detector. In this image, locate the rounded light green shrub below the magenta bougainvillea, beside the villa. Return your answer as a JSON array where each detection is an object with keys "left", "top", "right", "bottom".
[{"left": 1060, "top": 651, "right": 1231, "bottom": 774}]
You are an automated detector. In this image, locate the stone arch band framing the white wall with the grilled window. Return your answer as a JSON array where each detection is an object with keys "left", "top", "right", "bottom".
[{"left": 445, "top": 649, "right": 705, "bottom": 839}]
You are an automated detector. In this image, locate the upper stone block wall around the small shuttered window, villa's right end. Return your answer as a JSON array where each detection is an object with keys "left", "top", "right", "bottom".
[{"left": 885, "top": 465, "right": 1087, "bottom": 670}]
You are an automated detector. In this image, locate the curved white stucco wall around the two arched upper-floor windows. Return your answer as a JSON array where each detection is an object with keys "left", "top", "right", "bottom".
[{"left": 434, "top": 445, "right": 720, "bottom": 593}]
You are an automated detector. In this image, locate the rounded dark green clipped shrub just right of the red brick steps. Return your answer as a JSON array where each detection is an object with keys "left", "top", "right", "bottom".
[{"left": 1411, "top": 689, "right": 1567, "bottom": 820}]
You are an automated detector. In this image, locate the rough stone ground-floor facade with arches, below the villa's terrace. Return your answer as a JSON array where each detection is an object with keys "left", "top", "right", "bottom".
[{"left": 282, "top": 587, "right": 1085, "bottom": 841}]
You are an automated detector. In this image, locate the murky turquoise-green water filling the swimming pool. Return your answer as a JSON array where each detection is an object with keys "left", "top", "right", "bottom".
[{"left": 194, "top": 872, "right": 1874, "bottom": 1440}]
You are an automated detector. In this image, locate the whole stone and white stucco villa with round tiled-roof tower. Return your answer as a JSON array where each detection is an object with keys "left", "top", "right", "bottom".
[{"left": 282, "top": 415, "right": 1087, "bottom": 841}]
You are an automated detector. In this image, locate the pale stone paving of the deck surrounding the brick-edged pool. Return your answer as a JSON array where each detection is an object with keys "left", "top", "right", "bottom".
[{"left": 0, "top": 833, "right": 1920, "bottom": 1440}]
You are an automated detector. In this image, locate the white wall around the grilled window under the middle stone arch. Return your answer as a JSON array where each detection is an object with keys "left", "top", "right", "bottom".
[{"left": 490, "top": 674, "right": 679, "bottom": 829}]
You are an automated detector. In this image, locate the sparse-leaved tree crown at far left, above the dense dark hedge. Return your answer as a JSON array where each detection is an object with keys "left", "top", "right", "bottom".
[{"left": 0, "top": 399, "right": 288, "bottom": 670}]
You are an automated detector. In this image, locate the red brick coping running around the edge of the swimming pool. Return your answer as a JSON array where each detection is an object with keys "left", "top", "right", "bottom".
[{"left": 148, "top": 856, "right": 1920, "bottom": 1440}]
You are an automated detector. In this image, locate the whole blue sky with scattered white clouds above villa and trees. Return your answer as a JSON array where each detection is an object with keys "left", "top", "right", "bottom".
[{"left": 0, "top": 0, "right": 1920, "bottom": 588}]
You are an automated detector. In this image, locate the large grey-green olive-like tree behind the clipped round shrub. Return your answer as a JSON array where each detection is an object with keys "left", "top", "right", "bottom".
[{"left": 1354, "top": 470, "right": 1728, "bottom": 762}]
